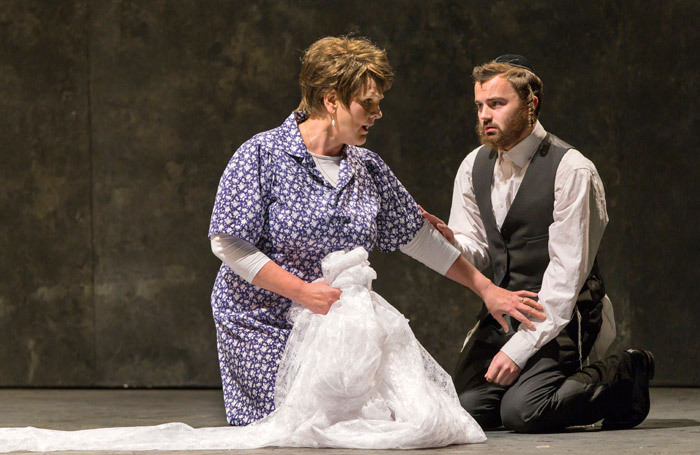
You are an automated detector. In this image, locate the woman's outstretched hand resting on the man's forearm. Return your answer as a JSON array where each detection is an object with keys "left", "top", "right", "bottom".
[{"left": 481, "top": 283, "right": 546, "bottom": 332}]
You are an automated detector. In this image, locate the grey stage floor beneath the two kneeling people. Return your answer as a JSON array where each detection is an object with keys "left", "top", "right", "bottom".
[{"left": 0, "top": 388, "right": 700, "bottom": 455}]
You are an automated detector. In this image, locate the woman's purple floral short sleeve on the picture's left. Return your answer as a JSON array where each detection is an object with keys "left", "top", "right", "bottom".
[{"left": 209, "top": 138, "right": 269, "bottom": 248}]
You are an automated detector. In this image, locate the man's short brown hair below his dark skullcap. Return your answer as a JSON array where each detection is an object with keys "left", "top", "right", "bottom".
[{"left": 472, "top": 62, "right": 542, "bottom": 124}]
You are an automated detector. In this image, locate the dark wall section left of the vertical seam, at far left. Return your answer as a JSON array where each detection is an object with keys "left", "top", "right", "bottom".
[{"left": 0, "top": 2, "right": 96, "bottom": 385}]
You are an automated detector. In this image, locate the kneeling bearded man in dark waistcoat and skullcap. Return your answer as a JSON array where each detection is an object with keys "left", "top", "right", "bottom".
[{"left": 424, "top": 55, "right": 654, "bottom": 432}]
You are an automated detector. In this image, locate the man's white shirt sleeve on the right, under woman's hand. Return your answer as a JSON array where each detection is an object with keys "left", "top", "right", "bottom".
[{"left": 501, "top": 150, "right": 608, "bottom": 368}]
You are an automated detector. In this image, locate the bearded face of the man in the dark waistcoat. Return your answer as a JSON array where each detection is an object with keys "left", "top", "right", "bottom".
[{"left": 474, "top": 75, "right": 531, "bottom": 150}]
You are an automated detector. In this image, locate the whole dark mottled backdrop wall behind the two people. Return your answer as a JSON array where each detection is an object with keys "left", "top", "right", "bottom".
[{"left": 0, "top": 0, "right": 700, "bottom": 386}]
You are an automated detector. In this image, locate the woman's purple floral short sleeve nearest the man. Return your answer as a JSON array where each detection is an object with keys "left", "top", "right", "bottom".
[{"left": 367, "top": 151, "right": 423, "bottom": 252}]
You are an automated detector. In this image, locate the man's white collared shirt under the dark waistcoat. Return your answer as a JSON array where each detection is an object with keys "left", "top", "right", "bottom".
[{"left": 448, "top": 122, "right": 608, "bottom": 368}]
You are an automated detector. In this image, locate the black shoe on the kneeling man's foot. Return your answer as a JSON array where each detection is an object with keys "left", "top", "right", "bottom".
[{"left": 603, "top": 349, "right": 654, "bottom": 430}]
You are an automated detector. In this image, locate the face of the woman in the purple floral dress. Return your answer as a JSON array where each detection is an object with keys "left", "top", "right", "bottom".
[{"left": 335, "top": 77, "right": 384, "bottom": 145}]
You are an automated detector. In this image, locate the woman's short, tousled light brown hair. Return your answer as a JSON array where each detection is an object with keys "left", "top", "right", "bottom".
[{"left": 297, "top": 36, "right": 394, "bottom": 117}]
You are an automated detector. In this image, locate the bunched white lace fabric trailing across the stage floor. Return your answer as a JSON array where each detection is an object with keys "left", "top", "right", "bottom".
[{"left": 0, "top": 248, "right": 486, "bottom": 452}]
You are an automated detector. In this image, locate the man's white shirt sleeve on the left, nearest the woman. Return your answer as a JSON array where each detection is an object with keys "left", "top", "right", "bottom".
[{"left": 447, "top": 149, "right": 490, "bottom": 270}]
